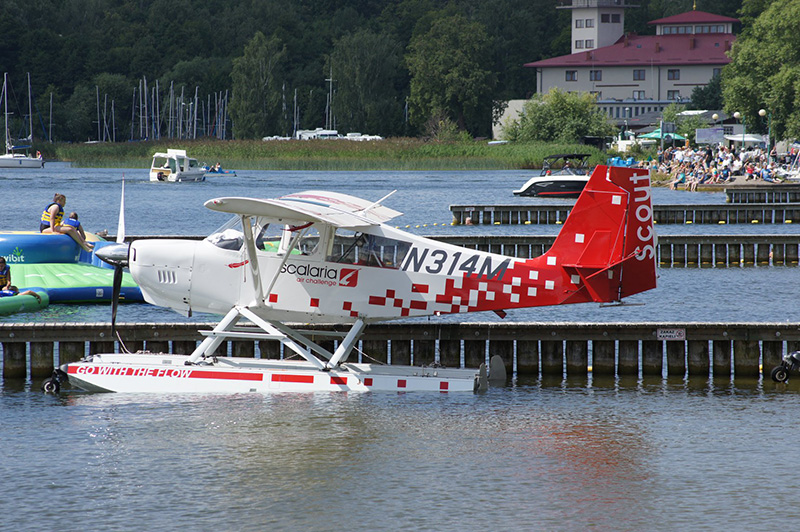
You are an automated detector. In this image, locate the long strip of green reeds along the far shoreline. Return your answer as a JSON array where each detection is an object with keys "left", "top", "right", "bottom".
[{"left": 54, "top": 138, "right": 606, "bottom": 170}]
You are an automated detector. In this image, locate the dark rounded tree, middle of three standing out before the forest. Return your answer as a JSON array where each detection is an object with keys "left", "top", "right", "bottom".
[{"left": 330, "top": 30, "right": 403, "bottom": 136}]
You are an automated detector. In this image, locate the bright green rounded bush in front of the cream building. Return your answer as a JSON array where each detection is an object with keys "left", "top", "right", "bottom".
[{"left": 503, "top": 88, "right": 614, "bottom": 142}]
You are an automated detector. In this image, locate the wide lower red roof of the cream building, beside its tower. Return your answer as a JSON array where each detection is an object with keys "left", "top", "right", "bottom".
[{"left": 523, "top": 33, "right": 736, "bottom": 68}]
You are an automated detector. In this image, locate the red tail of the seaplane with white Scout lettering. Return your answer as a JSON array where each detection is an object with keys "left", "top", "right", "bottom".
[{"left": 545, "top": 166, "right": 656, "bottom": 303}]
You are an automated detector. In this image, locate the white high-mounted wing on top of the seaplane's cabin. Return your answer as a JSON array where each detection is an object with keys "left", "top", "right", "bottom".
[{"left": 205, "top": 190, "right": 402, "bottom": 229}]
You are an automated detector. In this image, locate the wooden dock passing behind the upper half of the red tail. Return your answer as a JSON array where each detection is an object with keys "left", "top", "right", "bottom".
[{"left": 450, "top": 203, "right": 800, "bottom": 225}]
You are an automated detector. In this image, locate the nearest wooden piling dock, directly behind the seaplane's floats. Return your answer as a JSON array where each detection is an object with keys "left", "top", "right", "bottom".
[{"left": 0, "top": 323, "right": 800, "bottom": 384}]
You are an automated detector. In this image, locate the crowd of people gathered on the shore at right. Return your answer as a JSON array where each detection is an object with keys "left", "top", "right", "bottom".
[{"left": 653, "top": 146, "right": 792, "bottom": 191}]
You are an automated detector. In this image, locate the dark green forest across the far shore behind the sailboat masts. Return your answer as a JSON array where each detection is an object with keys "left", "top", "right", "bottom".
[{"left": 0, "top": 0, "right": 752, "bottom": 142}]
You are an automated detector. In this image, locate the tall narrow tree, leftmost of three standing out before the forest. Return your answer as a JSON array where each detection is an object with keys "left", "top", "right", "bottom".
[{"left": 230, "top": 32, "right": 288, "bottom": 139}]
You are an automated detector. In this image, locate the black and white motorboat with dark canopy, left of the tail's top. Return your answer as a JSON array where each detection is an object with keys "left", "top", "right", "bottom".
[{"left": 514, "top": 153, "right": 591, "bottom": 198}]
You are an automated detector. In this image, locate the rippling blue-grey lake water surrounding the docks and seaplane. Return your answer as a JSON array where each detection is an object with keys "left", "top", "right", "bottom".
[{"left": 0, "top": 163, "right": 800, "bottom": 531}]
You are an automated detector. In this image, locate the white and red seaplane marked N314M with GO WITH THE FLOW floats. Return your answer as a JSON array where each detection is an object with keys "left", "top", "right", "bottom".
[{"left": 50, "top": 166, "right": 656, "bottom": 393}]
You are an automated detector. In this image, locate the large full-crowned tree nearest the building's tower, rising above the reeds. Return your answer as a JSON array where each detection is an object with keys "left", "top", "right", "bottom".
[{"left": 406, "top": 15, "right": 496, "bottom": 134}]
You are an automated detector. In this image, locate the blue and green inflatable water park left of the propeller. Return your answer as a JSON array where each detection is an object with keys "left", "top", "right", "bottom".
[{"left": 0, "top": 231, "right": 144, "bottom": 315}]
